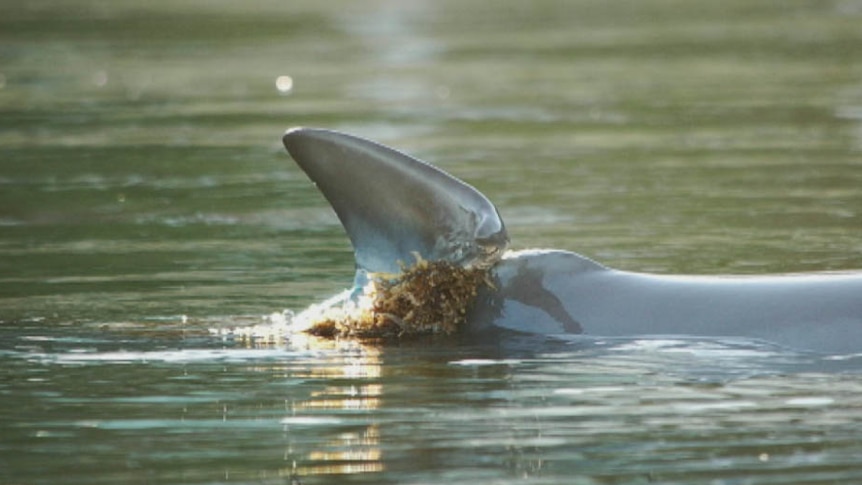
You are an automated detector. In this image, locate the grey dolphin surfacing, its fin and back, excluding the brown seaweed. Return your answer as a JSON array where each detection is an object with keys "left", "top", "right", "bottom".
[{"left": 283, "top": 128, "right": 862, "bottom": 354}]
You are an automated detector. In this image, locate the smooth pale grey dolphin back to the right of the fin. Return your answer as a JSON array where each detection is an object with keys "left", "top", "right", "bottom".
[{"left": 470, "top": 251, "right": 862, "bottom": 354}]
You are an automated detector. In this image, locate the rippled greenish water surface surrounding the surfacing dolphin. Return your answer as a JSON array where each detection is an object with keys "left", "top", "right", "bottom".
[{"left": 5, "top": 0, "right": 862, "bottom": 484}]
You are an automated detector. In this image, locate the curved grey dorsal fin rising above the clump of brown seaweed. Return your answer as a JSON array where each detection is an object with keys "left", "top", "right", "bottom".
[{"left": 282, "top": 128, "right": 508, "bottom": 273}]
